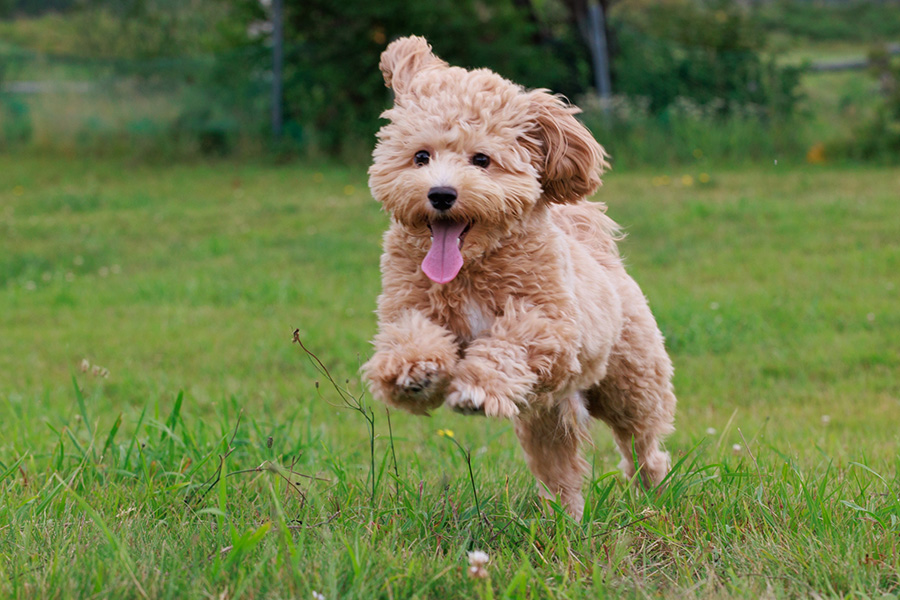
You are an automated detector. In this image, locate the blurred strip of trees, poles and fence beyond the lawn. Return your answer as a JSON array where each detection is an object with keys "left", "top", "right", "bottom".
[{"left": 0, "top": 0, "right": 900, "bottom": 167}]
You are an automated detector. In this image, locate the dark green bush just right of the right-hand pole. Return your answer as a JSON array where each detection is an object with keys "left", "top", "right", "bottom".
[{"left": 611, "top": 0, "right": 800, "bottom": 117}]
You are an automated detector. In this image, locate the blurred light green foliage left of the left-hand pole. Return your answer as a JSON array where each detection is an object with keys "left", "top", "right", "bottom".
[{"left": 0, "top": 0, "right": 270, "bottom": 158}]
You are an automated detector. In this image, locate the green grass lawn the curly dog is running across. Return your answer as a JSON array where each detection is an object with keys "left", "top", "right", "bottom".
[{"left": 0, "top": 156, "right": 900, "bottom": 599}]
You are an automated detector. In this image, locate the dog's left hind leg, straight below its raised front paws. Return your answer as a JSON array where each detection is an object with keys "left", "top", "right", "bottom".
[{"left": 515, "top": 394, "right": 589, "bottom": 519}]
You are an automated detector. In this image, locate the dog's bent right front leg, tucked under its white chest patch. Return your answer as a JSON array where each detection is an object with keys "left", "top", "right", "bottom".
[{"left": 447, "top": 302, "right": 579, "bottom": 418}]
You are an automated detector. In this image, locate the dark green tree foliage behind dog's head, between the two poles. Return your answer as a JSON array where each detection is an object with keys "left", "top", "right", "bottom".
[{"left": 285, "top": 0, "right": 589, "bottom": 157}]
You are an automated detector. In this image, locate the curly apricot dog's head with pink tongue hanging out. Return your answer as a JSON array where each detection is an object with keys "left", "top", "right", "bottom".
[{"left": 369, "top": 37, "right": 609, "bottom": 283}]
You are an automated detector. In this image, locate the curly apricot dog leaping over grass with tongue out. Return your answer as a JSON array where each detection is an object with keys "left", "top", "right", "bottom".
[{"left": 363, "top": 36, "right": 676, "bottom": 518}]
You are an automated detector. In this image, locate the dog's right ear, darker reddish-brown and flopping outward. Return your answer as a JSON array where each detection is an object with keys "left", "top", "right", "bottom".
[{"left": 526, "top": 90, "right": 610, "bottom": 203}]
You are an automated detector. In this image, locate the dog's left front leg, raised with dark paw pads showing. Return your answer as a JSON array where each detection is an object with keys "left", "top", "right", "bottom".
[{"left": 363, "top": 309, "right": 459, "bottom": 414}]
